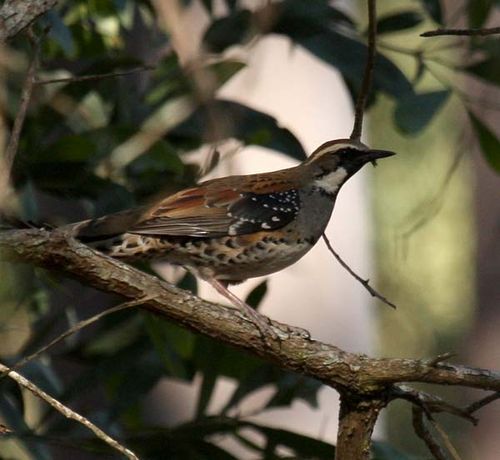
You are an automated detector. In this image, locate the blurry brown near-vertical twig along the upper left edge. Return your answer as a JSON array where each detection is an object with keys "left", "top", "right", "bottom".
[{"left": 4, "top": 28, "right": 42, "bottom": 180}]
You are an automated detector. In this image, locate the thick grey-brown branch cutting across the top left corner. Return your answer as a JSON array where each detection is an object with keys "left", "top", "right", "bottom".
[{"left": 0, "top": 0, "right": 57, "bottom": 43}]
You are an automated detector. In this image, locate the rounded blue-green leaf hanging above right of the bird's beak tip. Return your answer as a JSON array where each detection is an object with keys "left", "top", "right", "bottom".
[{"left": 394, "top": 90, "right": 450, "bottom": 134}]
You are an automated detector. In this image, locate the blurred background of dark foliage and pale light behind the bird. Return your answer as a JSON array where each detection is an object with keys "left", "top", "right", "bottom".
[{"left": 0, "top": 0, "right": 500, "bottom": 460}]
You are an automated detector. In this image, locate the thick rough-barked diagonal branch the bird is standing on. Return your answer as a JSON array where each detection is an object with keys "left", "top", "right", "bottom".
[{"left": 0, "top": 229, "right": 500, "bottom": 395}]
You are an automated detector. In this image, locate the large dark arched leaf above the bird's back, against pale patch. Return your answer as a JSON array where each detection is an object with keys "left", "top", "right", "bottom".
[{"left": 168, "top": 100, "right": 306, "bottom": 160}]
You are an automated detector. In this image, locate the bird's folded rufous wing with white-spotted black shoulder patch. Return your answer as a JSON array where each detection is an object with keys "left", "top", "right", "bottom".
[{"left": 128, "top": 176, "right": 300, "bottom": 237}]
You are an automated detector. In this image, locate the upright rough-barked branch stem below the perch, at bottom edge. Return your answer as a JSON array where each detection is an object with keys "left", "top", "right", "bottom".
[{"left": 335, "top": 394, "right": 387, "bottom": 460}]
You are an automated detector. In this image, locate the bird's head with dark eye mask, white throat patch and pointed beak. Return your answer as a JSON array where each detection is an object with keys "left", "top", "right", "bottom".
[{"left": 304, "top": 139, "right": 394, "bottom": 194}]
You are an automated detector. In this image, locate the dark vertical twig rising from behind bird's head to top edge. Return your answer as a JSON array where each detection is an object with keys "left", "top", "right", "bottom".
[{"left": 351, "top": 0, "right": 377, "bottom": 140}]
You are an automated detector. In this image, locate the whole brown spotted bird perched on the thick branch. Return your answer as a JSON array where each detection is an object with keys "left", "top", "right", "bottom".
[{"left": 71, "top": 139, "right": 394, "bottom": 344}]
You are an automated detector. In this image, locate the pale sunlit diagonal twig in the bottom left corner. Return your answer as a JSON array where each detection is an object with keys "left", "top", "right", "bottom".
[{"left": 0, "top": 363, "right": 139, "bottom": 460}]
